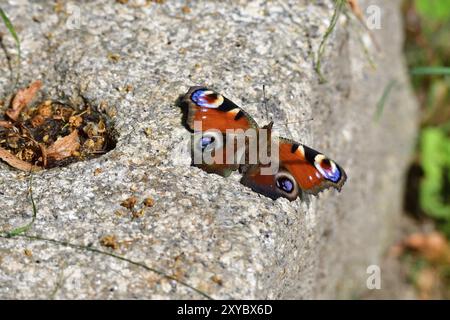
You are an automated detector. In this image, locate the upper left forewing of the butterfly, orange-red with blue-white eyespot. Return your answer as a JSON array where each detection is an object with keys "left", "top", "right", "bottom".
[{"left": 179, "top": 87, "right": 258, "bottom": 132}]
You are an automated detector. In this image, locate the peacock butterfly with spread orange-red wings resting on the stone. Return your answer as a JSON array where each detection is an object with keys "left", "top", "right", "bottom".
[{"left": 177, "top": 86, "right": 347, "bottom": 201}]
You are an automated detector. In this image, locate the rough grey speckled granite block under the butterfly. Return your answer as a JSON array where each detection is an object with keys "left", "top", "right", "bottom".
[{"left": 0, "top": 0, "right": 417, "bottom": 299}]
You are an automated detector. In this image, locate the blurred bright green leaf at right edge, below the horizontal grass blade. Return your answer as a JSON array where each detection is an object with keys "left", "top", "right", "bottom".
[{"left": 420, "top": 128, "right": 450, "bottom": 224}]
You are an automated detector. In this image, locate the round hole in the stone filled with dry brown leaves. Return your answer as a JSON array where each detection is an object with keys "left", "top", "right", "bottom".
[{"left": 0, "top": 93, "right": 116, "bottom": 170}]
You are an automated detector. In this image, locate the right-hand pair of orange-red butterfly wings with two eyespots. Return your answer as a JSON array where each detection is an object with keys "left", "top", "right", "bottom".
[{"left": 241, "top": 138, "right": 347, "bottom": 201}]
